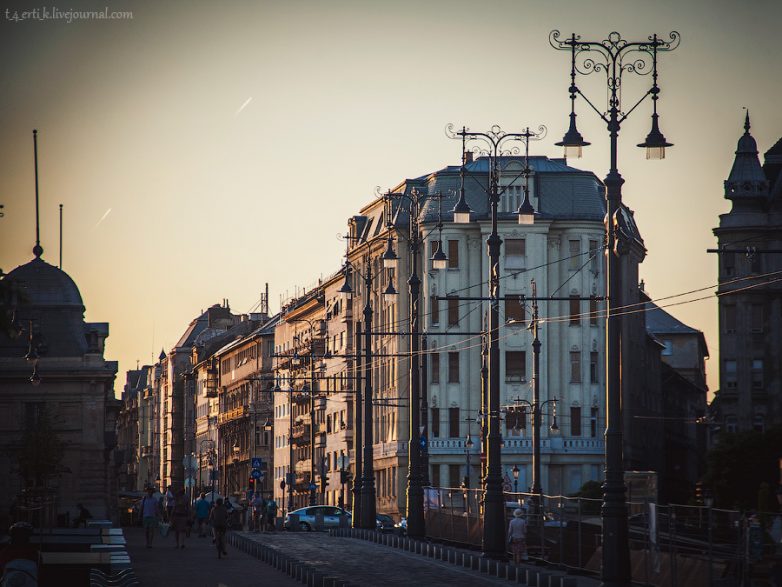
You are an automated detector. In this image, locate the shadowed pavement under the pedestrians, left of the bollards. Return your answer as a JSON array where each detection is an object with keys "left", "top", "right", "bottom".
[{"left": 125, "top": 528, "right": 301, "bottom": 587}]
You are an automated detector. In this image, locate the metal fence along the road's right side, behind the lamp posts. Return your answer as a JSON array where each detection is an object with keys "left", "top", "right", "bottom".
[{"left": 425, "top": 488, "right": 782, "bottom": 587}]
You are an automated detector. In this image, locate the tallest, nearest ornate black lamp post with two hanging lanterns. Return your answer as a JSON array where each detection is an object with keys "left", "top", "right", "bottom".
[{"left": 549, "top": 30, "right": 680, "bottom": 587}]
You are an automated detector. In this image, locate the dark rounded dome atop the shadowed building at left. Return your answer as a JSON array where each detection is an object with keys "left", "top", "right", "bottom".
[{"left": 5, "top": 257, "right": 84, "bottom": 311}]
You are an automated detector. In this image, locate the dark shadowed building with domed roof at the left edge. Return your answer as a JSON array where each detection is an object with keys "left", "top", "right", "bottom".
[{"left": 0, "top": 253, "right": 120, "bottom": 523}]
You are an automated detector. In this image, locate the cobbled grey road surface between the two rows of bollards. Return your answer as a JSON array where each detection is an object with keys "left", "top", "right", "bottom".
[{"left": 241, "top": 532, "right": 532, "bottom": 587}]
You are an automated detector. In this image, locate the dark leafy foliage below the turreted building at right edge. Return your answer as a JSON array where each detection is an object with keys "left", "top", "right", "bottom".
[{"left": 703, "top": 427, "right": 782, "bottom": 510}]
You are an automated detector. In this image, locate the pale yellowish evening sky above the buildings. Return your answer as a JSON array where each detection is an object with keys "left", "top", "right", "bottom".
[{"left": 0, "top": 0, "right": 782, "bottom": 392}]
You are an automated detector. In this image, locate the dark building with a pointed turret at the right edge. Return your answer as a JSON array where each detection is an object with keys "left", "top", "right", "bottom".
[{"left": 714, "top": 114, "right": 782, "bottom": 432}]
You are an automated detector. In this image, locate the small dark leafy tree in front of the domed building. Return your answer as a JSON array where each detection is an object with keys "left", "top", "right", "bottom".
[{"left": 18, "top": 405, "right": 64, "bottom": 487}]
